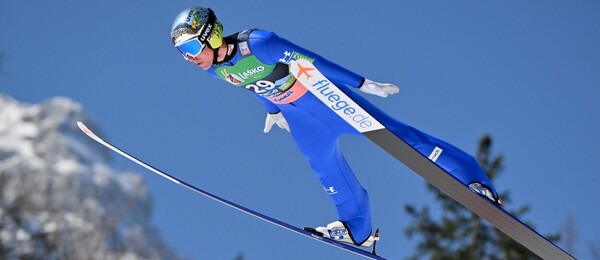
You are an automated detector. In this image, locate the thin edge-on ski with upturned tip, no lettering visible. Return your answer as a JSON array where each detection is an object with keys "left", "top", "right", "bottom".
[{"left": 77, "top": 122, "right": 385, "bottom": 260}]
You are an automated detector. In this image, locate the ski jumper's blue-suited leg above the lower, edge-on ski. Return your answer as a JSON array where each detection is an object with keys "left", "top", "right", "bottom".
[{"left": 282, "top": 98, "right": 372, "bottom": 243}]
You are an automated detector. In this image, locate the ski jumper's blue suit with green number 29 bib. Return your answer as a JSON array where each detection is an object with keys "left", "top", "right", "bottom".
[{"left": 208, "top": 30, "right": 497, "bottom": 244}]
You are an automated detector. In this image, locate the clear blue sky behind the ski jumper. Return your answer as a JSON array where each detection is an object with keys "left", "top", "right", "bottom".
[{"left": 0, "top": 0, "right": 600, "bottom": 259}]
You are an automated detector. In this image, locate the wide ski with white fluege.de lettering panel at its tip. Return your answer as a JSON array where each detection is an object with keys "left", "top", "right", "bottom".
[{"left": 290, "top": 59, "right": 575, "bottom": 259}]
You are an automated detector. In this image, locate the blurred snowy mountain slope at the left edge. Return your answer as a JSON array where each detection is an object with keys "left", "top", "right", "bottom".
[{"left": 0, "top": 93, "right": 179, "bottom": 259}]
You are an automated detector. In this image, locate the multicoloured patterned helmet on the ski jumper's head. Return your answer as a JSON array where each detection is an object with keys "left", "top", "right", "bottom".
[{"left": 171, "top": 7, "right": 223, "bottom": 50}]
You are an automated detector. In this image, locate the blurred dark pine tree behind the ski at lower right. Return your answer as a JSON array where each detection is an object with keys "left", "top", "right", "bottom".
[{"left": 405, "top": 135, "right": 559, "bottom": 259}]
